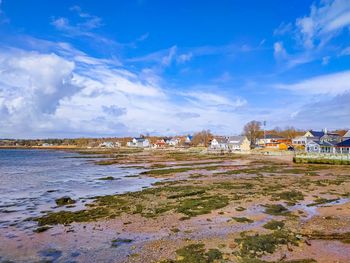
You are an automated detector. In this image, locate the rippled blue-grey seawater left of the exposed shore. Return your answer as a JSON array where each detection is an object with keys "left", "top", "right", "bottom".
[{"left": 0, "top": 150, "right": 155, "bottom": 228}]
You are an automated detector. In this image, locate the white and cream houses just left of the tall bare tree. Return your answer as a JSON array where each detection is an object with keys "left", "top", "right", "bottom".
[{"left": 208, "top": 136, "right": 250, "bottom": 152}]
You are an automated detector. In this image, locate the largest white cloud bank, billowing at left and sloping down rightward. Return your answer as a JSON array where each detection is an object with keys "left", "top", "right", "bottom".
[{"left": 0, "top": 42, "right": 253, "bottom": 138}]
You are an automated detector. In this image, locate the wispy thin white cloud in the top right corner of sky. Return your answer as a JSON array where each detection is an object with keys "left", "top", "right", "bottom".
[{"left": 274, "top": 0, "right": 350, "bottom": 69}]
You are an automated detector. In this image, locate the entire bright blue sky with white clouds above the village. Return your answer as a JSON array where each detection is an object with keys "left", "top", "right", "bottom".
[{"left": 0, "top": 0, "right": 350, "bottom": 138}]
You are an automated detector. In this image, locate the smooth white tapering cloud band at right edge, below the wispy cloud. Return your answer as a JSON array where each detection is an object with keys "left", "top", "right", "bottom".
[{"left": 276, "top": 71, "right": 350, "bottom": 95}]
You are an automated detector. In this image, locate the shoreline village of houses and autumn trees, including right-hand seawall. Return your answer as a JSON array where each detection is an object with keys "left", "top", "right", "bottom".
[{"left": 0, "top": 129, "right": 350, "bottom": 164}]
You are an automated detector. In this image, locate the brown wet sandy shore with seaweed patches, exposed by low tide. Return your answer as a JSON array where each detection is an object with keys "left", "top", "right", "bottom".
[{"left": 0, "top": 151, "right": 350, "bottom": 262}]
